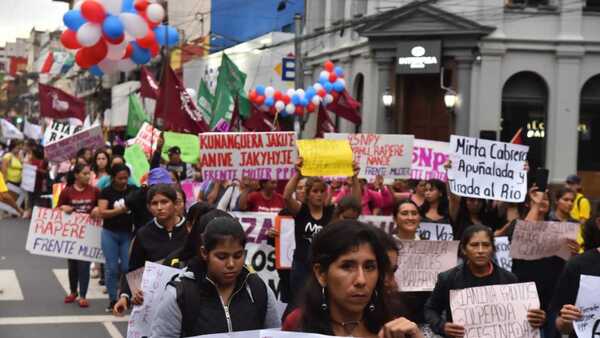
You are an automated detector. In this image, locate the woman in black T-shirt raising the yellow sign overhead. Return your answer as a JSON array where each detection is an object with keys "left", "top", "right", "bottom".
[{"left": 283, "top": 158, "right": 361, "bottom": 308}]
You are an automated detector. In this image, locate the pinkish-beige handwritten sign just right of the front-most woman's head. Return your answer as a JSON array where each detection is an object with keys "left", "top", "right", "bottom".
[{"left": 394, "top": 240, "right": 458, "bottom": 291}]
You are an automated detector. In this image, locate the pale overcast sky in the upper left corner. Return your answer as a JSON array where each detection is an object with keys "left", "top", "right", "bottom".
[{"left": 0, "top": 0, "right": 69, "bottom": 46}]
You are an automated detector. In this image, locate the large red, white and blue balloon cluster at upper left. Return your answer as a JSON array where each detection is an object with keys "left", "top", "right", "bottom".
[{"left": 60, "top": 0, "right": 179, "bottom": 76}]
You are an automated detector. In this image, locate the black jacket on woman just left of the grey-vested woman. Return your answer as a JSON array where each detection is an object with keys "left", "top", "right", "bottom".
[{"left": 121, "top": 217, "right": 187, "bottom": 297}]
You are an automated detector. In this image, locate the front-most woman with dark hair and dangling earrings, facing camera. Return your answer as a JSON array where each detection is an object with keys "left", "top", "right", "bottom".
[{"left": 283, "top": 220, "right": 422, "bottom": 337}]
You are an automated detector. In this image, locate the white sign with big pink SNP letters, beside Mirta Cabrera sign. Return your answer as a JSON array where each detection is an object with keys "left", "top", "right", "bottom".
[{"left": 410, "top": 139, "right": 449, "bottom": 182}]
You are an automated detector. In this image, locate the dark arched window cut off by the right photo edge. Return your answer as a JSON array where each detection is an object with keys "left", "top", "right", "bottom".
[{"left": 577, "top": 74, "right": 600, "bottom": 171}]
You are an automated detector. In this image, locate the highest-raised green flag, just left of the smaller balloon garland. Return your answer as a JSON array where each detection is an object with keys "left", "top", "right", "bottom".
[{"left": 210, "top": 53, "right": 249, "bottom": 129}]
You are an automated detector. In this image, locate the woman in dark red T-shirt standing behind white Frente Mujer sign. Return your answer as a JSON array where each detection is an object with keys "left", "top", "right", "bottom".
[{"left": 57, "top": 164, "right": 100, "bottom": 307}]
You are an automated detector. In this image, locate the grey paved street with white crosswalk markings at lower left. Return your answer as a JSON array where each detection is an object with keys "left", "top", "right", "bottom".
[{"left": 0, "top": 218, "right": 127, "bottom": 338}]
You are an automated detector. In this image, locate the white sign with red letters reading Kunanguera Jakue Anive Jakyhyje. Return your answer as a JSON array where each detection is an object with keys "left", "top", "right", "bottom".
[{"left": 200, "top": 132, "right": 296, "bottom": 180}]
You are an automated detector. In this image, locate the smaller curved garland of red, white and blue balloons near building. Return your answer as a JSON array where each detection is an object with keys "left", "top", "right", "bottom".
[{"left": 248, "top": 61, "right": 346, "bottom": 116}]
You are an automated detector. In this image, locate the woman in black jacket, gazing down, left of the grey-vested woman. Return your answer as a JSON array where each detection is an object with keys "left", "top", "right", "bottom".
[{"left": 113, "top": 184, "right": 187, "bottom": 315}]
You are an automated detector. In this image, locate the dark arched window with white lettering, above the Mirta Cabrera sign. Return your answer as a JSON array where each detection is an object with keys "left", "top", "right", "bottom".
[{"left": 500, "top": 72, "right": 548, "bottom": 168}]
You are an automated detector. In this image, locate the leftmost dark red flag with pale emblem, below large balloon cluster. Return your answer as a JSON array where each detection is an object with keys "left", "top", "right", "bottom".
[{"left": 38, "top": 83, "right": 85, "bottom": 122}]
